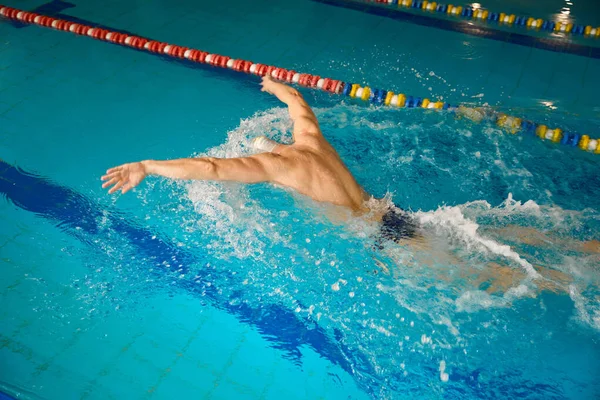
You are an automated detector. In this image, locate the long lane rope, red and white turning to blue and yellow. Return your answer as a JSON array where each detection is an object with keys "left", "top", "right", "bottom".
[{"left": 0, "top": 6, "right": 600, "bottom": 154}]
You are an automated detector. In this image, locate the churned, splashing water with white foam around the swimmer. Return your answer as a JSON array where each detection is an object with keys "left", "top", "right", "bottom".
[{"left": 135, "top": 105, "right": 600, "bottom": 398}]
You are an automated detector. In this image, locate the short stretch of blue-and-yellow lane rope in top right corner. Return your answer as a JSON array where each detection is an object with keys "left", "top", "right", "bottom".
[{"left": 372, "top": 0, "right": 600, "bottom": 38}]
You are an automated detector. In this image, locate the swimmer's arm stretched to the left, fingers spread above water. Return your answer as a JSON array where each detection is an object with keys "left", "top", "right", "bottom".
[{"left": 102, "top": 153, "right": 283, "bottom": 193}]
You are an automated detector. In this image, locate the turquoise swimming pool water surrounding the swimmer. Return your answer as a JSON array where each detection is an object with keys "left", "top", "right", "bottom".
[{"left": 0, "top": 0, "right": 600, "bottom": 399}]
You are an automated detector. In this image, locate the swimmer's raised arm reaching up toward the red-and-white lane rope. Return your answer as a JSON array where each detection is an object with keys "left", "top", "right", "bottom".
[{"left": 262, "top": 75, "right": 321, "bottom": 141}]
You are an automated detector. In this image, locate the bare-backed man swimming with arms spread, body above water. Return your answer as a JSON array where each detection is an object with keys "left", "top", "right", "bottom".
[{"left": 102, "top": 76, "right": 416, "bottom": 241}]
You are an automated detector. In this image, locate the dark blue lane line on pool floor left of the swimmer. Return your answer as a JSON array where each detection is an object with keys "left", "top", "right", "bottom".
[{"left": 0, "top": 160, "right": 377, "bottom": 393}]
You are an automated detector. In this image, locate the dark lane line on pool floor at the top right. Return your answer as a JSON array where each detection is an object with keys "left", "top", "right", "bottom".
[{"left": 312, "top": 0, "right": 600, "bottom": 59}]
